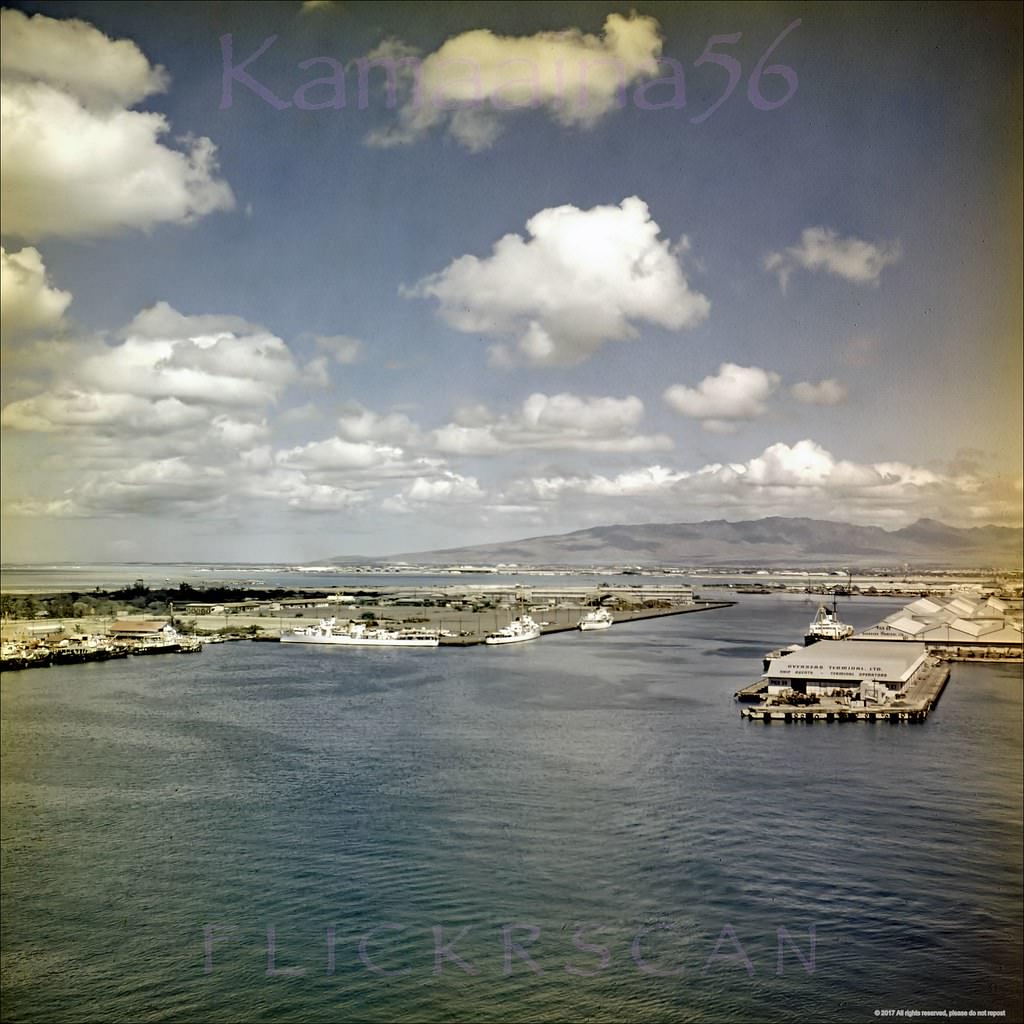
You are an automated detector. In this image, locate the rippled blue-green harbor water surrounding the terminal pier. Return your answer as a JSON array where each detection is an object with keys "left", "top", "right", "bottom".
[{"left": 0, "top": 597, "right": 1022, "bottom": 1022}]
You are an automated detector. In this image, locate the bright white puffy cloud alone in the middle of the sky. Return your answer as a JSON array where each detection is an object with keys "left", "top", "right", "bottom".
[{"left": 403, "top": 196, "right": 711, "bottom": 366}]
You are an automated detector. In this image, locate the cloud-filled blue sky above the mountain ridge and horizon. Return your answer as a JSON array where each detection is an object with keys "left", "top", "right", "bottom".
[{"left": 0, "top": 2, "right": 1024, "bottom": 563}]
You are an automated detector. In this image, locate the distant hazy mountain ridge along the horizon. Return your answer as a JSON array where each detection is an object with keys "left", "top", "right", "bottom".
[{"left": 325, "top": 516, "right": 1024, "bottom": 568}]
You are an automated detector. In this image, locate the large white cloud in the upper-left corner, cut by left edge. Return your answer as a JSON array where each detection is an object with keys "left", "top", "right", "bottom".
[{"left": 0, "top": 10, "right": 234, "bottom": 241}]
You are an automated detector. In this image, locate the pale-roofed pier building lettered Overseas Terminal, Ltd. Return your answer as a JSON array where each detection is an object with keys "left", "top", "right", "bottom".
[{"left": 765, "top": 640, "right": 928, "bottom": 703}]
